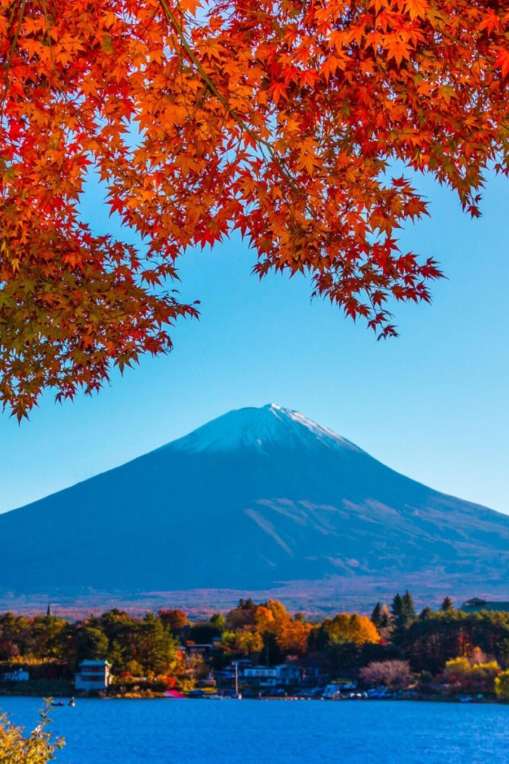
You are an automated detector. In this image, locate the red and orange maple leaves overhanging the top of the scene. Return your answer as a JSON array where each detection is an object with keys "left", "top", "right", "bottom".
[{"left": 0, "top": 0, "right": 509, "bottom": 417}]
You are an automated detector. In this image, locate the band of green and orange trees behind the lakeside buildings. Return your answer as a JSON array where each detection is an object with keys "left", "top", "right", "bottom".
[{"left": 0, "top": 592, "right": 509, "bottom": 686}]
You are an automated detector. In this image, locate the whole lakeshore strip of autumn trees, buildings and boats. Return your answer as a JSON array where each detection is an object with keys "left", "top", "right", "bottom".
[{"left": 0, "top": 591, "right": 509, "bottom": 705}]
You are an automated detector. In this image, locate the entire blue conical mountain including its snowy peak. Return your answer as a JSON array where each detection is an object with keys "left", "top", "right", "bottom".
[{"left": 0, "top": 405, "right": 509, "bottom": 594}]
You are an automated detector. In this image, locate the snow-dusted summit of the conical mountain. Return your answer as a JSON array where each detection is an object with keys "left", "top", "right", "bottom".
[{"left": 166, "top": 403, "right": 360, "bottom": 453}]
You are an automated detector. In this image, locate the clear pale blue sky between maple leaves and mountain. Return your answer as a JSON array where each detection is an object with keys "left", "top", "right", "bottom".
[{"left": 0, "top": 170, "right": 509, "bottom": 513}]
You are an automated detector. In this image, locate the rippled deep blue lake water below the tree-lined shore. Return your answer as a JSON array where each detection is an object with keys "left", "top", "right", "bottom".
[{"left": 0, "top": 697, "right": 509, "bottom": 764}]
